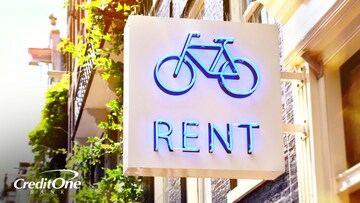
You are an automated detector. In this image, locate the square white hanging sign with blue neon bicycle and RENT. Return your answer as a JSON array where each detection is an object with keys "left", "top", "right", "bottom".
[{"left": 123, "top": 16, "right": 284, "bottom": 179}]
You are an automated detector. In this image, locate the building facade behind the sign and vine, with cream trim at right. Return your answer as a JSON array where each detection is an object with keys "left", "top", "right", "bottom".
[{"left": 66, "top": 0, "right": 360, "bottom": 202}]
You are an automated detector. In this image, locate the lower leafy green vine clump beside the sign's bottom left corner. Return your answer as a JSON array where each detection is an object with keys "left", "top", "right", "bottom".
[{"left": 67, "top": 101, "right": 143, "bottom": 202}]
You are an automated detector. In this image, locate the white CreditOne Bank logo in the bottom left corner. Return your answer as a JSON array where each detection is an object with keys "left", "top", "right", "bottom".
[{"left": 14, "top": 169, "right": 81, "bottom": 190}]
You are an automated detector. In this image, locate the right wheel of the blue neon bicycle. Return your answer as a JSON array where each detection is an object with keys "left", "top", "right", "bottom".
[{"left": 218, "top": 58, "right": 260, "bottom": 98}]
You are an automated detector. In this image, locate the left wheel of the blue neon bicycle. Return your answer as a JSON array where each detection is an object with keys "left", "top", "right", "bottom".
[{"left": 154, "top": 55, "right": 195, "bottom": 95}]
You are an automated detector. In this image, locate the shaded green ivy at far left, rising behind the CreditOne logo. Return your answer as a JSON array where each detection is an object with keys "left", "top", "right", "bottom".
[{"left": 28, "top": 75, "right": 69, "bottom": 202}]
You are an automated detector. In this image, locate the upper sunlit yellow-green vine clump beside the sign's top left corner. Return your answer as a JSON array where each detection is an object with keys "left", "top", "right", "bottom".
[{"left": 59, "top": 0, "right": 140, "bottom": 84}]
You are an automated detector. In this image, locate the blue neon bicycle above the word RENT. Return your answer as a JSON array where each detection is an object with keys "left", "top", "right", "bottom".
[{"left": 154, "top": 32, "right": 260, "bottom": 98}]
